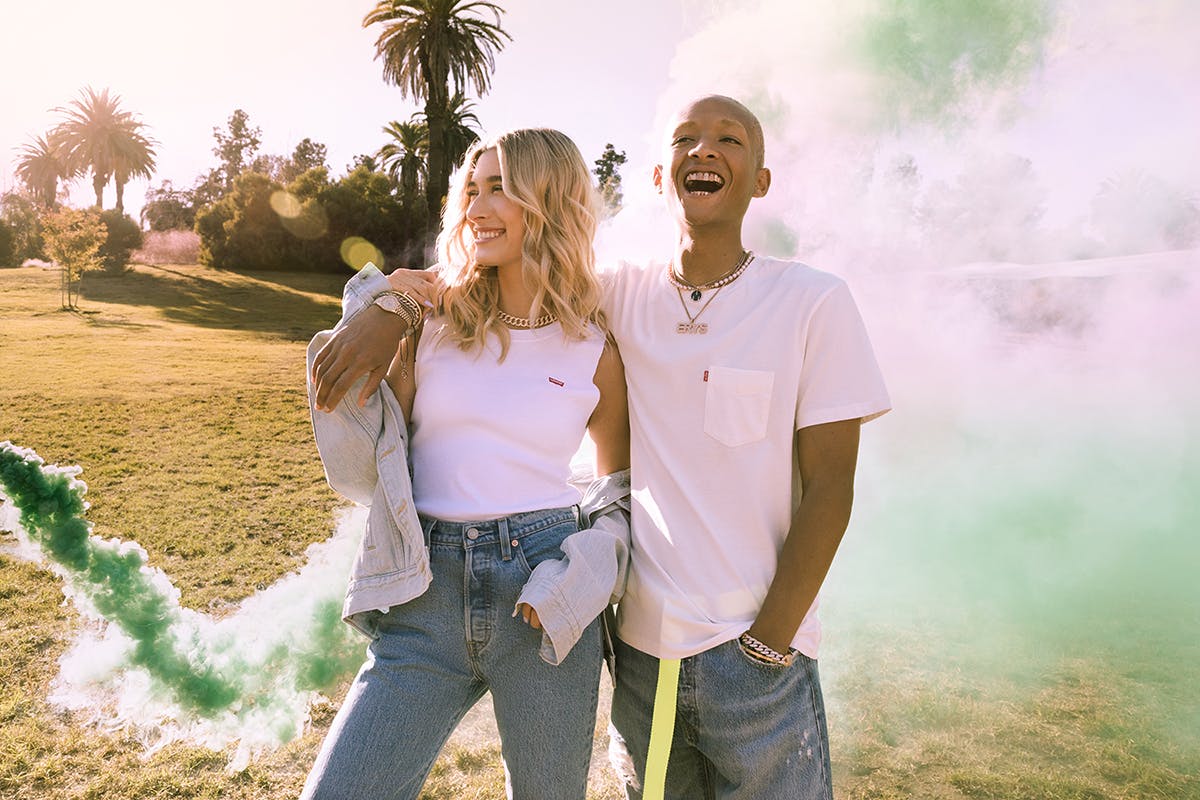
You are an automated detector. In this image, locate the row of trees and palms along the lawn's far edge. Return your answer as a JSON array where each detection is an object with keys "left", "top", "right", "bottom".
[{"left": 0, "top": 0, "right": 625, "bottom": 281}]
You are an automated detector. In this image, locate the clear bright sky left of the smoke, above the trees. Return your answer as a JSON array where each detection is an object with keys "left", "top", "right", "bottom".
[{"left": 0, "top": 0, "right": 696, "bottom": 219}]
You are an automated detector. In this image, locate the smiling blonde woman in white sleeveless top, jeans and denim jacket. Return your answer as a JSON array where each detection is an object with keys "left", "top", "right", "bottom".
[{"left": 302, "top": 130, "right": 629, "bottom": 800}]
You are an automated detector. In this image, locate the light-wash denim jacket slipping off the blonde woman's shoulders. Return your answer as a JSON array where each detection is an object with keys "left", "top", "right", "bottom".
[{"left": 307, "top": 265, "right": 630, "bottom": 664}]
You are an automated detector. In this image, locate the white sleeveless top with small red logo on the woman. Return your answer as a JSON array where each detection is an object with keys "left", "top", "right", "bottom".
[{"left": 412, "top": 319, "right": 604, "bottom": 522}]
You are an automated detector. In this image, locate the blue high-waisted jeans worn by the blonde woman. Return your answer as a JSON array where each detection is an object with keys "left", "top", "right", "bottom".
[{"left": 301, "top": 507, "right": 602, "bottom": 800}]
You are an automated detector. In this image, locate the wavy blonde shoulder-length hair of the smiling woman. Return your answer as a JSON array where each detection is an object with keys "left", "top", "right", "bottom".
[{"left": 438, "top": 128, "right": 606, "bottom": 361}]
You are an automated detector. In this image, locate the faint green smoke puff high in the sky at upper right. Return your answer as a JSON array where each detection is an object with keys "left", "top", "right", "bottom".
[{"left": 860, "top": 0, "right": 1052, "bottom": 124}]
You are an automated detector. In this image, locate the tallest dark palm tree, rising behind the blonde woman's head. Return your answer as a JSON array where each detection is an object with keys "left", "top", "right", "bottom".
[{"left": 362, "top": 0, "right": 512, "bottom": 226}]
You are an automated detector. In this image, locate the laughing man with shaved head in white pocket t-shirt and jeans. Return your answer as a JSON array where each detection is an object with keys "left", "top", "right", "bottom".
[{"left": 309, "top": 96, "right": 890, "bottom": 800}]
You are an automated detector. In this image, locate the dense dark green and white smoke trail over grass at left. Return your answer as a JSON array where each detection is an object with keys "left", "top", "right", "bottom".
[{"left": 0, "top": 441, "right": 362, "bottom": 760}]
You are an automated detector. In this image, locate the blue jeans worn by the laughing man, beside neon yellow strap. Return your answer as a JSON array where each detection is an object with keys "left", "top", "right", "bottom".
[{"left": 610, "top": 639, "right": 833, "bottom": 800}]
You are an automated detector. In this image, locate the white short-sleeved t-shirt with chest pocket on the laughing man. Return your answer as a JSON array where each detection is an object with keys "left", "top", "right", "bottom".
[{"left": 606, "top": 258, "right": 890, "bottom": 658}]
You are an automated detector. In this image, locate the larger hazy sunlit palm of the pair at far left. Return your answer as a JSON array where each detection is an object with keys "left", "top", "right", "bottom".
[{"left": 54, "top": 86, "right": 156, "bottom": 212}]
